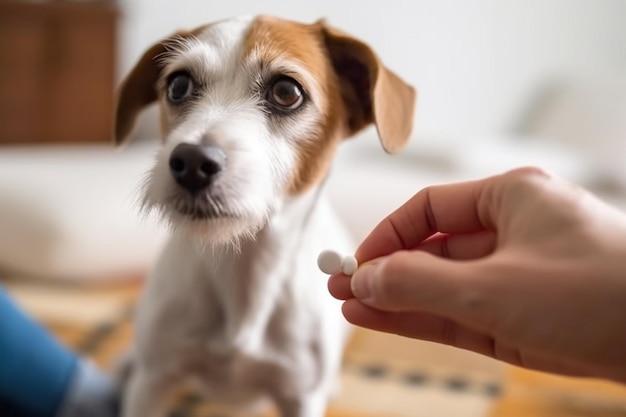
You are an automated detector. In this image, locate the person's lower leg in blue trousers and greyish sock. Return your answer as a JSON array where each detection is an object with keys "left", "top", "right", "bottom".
[{"left": 0, "top": 287, "right": 117, "bottom": 417}]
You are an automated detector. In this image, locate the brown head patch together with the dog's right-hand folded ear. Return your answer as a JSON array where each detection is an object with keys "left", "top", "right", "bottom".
[{"left": 244, "top": 16, "right": 416, "bottom": 195}]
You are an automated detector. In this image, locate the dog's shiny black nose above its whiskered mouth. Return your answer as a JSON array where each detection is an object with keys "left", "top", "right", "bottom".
[{"left": 170, "top": 143, "right": 226, "bottom": 193}]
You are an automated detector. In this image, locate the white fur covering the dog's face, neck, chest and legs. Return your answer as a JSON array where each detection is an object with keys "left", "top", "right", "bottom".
[{"left": 118, "top": 14, "right": 412, "bottom": 417}]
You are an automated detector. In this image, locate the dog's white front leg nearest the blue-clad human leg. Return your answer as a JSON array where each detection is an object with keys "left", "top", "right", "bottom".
[{"left": 122, "top": 367, "right": 173, "bottom": 417}]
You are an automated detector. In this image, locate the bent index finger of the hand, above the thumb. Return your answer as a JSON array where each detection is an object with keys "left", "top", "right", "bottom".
[{"left": 355, "top": 177, "right": 498, "bottom": 263}]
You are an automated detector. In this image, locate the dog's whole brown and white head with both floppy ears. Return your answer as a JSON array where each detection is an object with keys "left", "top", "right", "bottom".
[{"left": 115, "top": 16, "right": 416, "bottom": 242}]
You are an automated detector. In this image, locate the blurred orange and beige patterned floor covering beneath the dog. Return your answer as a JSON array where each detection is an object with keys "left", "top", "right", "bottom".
[{"left": 3, "top": 280, "right": 626, "bottom": 417}]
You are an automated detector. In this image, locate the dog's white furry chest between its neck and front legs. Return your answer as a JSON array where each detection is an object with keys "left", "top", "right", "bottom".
[{"left": 139, "top": 234, "right": 324, "bottom": 390}]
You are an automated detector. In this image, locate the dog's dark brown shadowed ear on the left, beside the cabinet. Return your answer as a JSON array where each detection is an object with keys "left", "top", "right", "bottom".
[{"left": 114, "top": 31, "right": 193, "bottom": 145}]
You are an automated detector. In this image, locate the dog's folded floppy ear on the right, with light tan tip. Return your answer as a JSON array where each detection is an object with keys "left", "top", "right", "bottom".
[{"left": 318, "top": 21, "right": 417, "bottom": 153}]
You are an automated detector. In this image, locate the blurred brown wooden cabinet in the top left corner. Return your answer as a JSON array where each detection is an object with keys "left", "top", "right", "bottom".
[{"left": 0, "top": 0, "right": 117, "bottom": 143}]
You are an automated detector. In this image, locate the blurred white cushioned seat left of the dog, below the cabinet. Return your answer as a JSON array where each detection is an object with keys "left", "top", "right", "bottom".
[{"left": 0, "top": 143, "right": 166, "bottom": 281}]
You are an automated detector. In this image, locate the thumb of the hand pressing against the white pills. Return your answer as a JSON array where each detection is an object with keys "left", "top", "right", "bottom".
[{"left": 350, "top": 251, "right": 488, "bottom": 318}]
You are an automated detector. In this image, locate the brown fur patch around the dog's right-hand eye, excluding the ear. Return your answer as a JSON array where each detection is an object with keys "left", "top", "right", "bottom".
[{"left": 244, "top": 16, "right": 348, "bottom": 195}]
